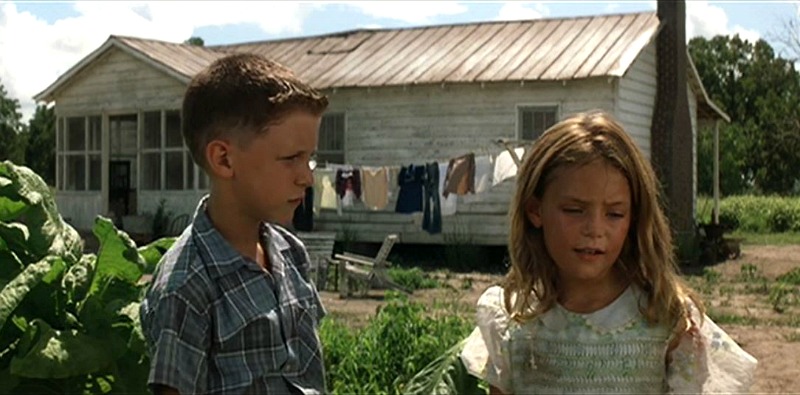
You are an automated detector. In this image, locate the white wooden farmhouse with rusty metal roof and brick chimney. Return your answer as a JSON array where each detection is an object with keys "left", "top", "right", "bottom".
[{"left": 35, "top": 2, "right": 727, "bottom": 245}]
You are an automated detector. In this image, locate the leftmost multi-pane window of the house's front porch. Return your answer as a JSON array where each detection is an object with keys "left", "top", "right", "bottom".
[{"left": 56, "top": 116, "right": 102, "bottom": 191}]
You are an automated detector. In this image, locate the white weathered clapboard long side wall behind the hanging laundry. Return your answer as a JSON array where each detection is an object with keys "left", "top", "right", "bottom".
[{"left": 316, "top": 78, "right": 614, "bottom": 245}]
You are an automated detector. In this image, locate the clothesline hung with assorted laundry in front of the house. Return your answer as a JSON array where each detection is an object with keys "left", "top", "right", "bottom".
[{"left": 306, "top": 139, "right": 529, "bottom": 233}]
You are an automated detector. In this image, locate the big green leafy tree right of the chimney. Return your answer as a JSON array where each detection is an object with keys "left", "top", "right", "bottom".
[{"left": 689, "top": 35, "right": 800, "bottom": 194}]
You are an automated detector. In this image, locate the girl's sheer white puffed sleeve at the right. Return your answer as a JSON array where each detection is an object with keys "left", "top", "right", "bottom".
[{"left": 667, "top": 302, "right": 758, "bottom": 394}]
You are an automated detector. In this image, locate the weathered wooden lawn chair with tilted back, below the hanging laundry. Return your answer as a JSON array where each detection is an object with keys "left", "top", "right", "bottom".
[{"left": 334, "top": 234, "right": 411, "bottom": 298}]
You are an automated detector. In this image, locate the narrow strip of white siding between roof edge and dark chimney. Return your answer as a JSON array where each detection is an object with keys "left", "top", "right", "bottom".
[{"left": 615, "top": 42, "right": 656, "bottom": 159}]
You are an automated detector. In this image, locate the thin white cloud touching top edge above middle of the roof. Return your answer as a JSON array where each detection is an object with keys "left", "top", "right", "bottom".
[{"left": 343, "top": 1, "right": 468, "bottom": 24}]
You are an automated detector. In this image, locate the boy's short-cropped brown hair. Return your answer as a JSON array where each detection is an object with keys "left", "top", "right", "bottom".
[{"left": 181, "top": 54, "right": 328, "bottom": 168}]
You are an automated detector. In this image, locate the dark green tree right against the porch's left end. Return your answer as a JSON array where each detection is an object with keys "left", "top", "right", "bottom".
[{"left": 25, "top": 105, "right": 56, "bottom": 185}]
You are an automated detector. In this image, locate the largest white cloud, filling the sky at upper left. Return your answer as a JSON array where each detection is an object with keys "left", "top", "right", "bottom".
[{"left": 0, "top": 1, "right": 324, "bottom": 120}]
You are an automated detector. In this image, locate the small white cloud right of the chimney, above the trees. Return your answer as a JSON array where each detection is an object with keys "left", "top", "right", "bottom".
[{"left": 686, "top": 1, "right": 761, "bottom": 41}]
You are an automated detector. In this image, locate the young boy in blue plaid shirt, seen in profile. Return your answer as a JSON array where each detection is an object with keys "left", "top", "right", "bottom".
[{"left": 141, "top": 54, "right": 328, "bottom": 394}]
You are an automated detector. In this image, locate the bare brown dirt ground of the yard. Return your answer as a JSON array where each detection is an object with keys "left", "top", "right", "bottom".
[{"left": 321, "top": 246, "right": 800, "bottom": 394}]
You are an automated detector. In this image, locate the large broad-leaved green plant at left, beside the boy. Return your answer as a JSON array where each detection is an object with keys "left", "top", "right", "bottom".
[{"left": 0, "top": 161, "right": 174, "bottom": 394}]
